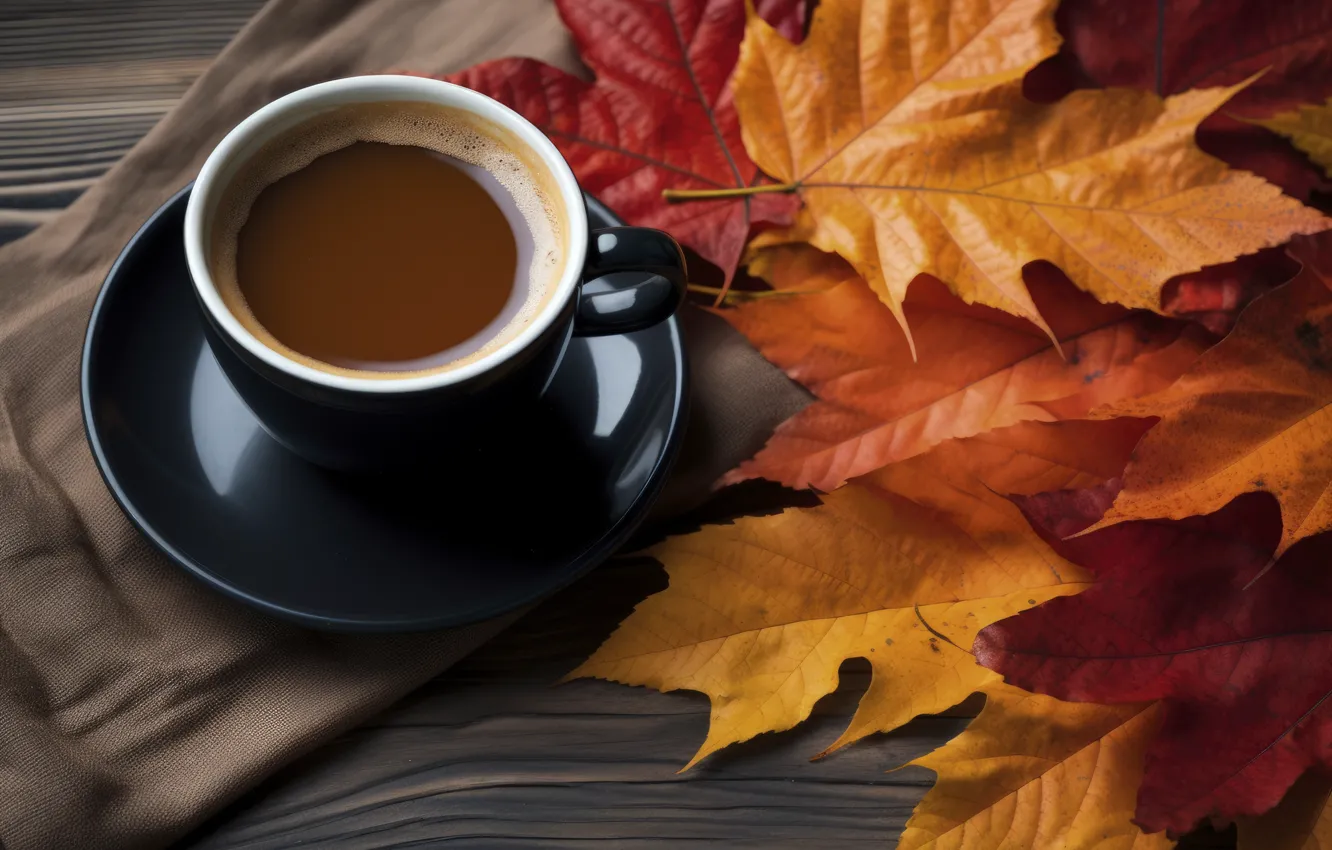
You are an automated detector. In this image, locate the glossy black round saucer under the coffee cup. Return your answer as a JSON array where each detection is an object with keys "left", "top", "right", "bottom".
[{"left": 83, "top": 188, "right": 686, "bottom": 632}]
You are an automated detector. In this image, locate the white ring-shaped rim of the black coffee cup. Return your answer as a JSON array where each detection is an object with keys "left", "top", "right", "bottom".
[{"left": 185, "top": 75, "right": 587, "bottom": 394}]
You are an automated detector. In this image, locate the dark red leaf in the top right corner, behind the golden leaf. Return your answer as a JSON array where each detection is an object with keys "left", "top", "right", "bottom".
[{"left": 1058, "top": 0, "right": 1332, "bottom": 201}]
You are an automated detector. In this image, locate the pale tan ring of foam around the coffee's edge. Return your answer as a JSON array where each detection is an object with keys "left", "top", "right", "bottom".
[{"left": 209, "top": 101, "right": 566, "bottom": 381}]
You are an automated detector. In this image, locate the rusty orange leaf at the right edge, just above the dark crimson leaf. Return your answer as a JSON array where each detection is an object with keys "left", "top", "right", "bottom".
[{"left": 1095, "top": 234, "right": 1332, "bottom": 556}]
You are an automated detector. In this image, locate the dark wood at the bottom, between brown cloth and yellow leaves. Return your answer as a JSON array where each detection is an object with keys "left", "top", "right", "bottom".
[{"left": 184, "top": 560, "right": 967, "bottom": 850}]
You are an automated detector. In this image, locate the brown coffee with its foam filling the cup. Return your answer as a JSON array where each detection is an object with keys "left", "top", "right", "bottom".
[{"left": 210, "top": 103, "right": 565, "bottom": 378}]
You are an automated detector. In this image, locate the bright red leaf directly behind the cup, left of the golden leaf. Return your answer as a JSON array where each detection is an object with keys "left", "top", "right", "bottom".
[{"left": 448, "top": 0, "right": 805, "bottom": 282}]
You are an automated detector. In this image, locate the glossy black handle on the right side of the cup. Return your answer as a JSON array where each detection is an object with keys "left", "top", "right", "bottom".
[{"left": 574, "top": 228, "right": 689, "bottom": 337}]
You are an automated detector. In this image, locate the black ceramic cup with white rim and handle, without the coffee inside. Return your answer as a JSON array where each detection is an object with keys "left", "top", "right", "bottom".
[{"left": 185, "top": 75, "right": 686, "bottom": 472}]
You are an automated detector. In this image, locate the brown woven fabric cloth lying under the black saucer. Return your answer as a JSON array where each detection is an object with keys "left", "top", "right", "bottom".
[{"left": 0, "top": 0, "right": 803, "bottom": 850}]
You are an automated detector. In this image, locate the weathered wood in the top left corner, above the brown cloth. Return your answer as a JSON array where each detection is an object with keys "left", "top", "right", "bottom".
[{"left": 0, "top": 0, "right": 262, "bottom": 244}]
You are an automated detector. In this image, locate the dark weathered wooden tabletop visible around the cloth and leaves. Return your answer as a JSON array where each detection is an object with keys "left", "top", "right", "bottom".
[{"left": 0, "top": 0, "right": 1228, "bottom": 850}]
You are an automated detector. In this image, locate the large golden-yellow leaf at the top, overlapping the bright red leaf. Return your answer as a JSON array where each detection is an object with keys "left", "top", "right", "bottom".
[{"left": 734, "top": 0, "right": 1332, "bottom": 343}]
